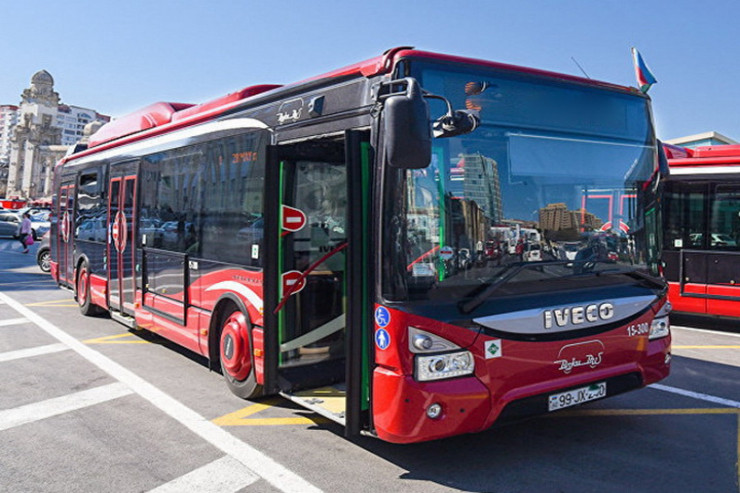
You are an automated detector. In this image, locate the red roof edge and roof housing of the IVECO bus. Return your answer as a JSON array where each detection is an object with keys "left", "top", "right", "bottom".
[{"left": 66, "top": 47, "right": 642, "bottom": 164}]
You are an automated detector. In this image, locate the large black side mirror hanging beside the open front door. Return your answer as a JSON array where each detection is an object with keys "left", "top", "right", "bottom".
[{"left": 379, "top": 77, "right": 432, "bottom": 169}]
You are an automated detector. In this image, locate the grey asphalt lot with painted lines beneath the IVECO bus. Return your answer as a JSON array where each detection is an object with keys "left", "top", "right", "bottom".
[{"left": 0, "top": 236, "right": 740, "bottom": 492}]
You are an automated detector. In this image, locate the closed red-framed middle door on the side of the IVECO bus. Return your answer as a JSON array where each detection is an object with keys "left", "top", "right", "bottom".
[{"left": 108, "top": 163, "right": 137, "bottom": 315}]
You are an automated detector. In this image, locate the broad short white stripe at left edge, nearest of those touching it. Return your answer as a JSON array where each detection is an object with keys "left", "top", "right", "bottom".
[{"left": 0, "top": 382, "right": 133, "bottom": 431}]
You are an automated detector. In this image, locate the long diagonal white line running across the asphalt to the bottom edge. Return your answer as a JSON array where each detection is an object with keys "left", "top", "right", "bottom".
[{"left": 0, "top": 292, "right": 321, "bottom": 493}]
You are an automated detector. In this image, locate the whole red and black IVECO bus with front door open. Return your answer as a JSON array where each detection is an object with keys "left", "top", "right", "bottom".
[{"left": 47, "top": 48, "right": 670, "bottom": 443}]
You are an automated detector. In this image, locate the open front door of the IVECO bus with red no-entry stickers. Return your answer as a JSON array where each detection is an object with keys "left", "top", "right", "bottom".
[{"left": 265, "top": 131, "right": 368, "bottom": 434}]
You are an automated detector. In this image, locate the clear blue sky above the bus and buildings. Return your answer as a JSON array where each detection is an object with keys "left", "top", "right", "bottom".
[{"left": 0, "top": 0, "right": 740, "bottom": 141}]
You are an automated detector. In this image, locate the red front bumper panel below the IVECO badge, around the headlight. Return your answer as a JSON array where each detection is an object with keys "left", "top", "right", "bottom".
[{"left": 373, "top": 303, "right": 671, "bottom": 443}]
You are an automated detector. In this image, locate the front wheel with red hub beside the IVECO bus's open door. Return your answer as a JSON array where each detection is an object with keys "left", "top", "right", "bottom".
[{"left": 219, "top": 307, "right": 262, "bottom": 399}]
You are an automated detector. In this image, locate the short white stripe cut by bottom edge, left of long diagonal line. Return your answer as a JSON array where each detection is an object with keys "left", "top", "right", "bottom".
[{"left": 149, "top": 455, "right": 259, "bottom": 493}]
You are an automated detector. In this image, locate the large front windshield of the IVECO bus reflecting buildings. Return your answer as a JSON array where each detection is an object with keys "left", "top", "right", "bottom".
[{"left": 384, "top": 62, "right": 658, "bottom": 301}]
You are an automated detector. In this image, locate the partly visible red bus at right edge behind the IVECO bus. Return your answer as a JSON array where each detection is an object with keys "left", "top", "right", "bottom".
[{"left": 663, "top": 145, "right": 740, "bottom": 317}]
